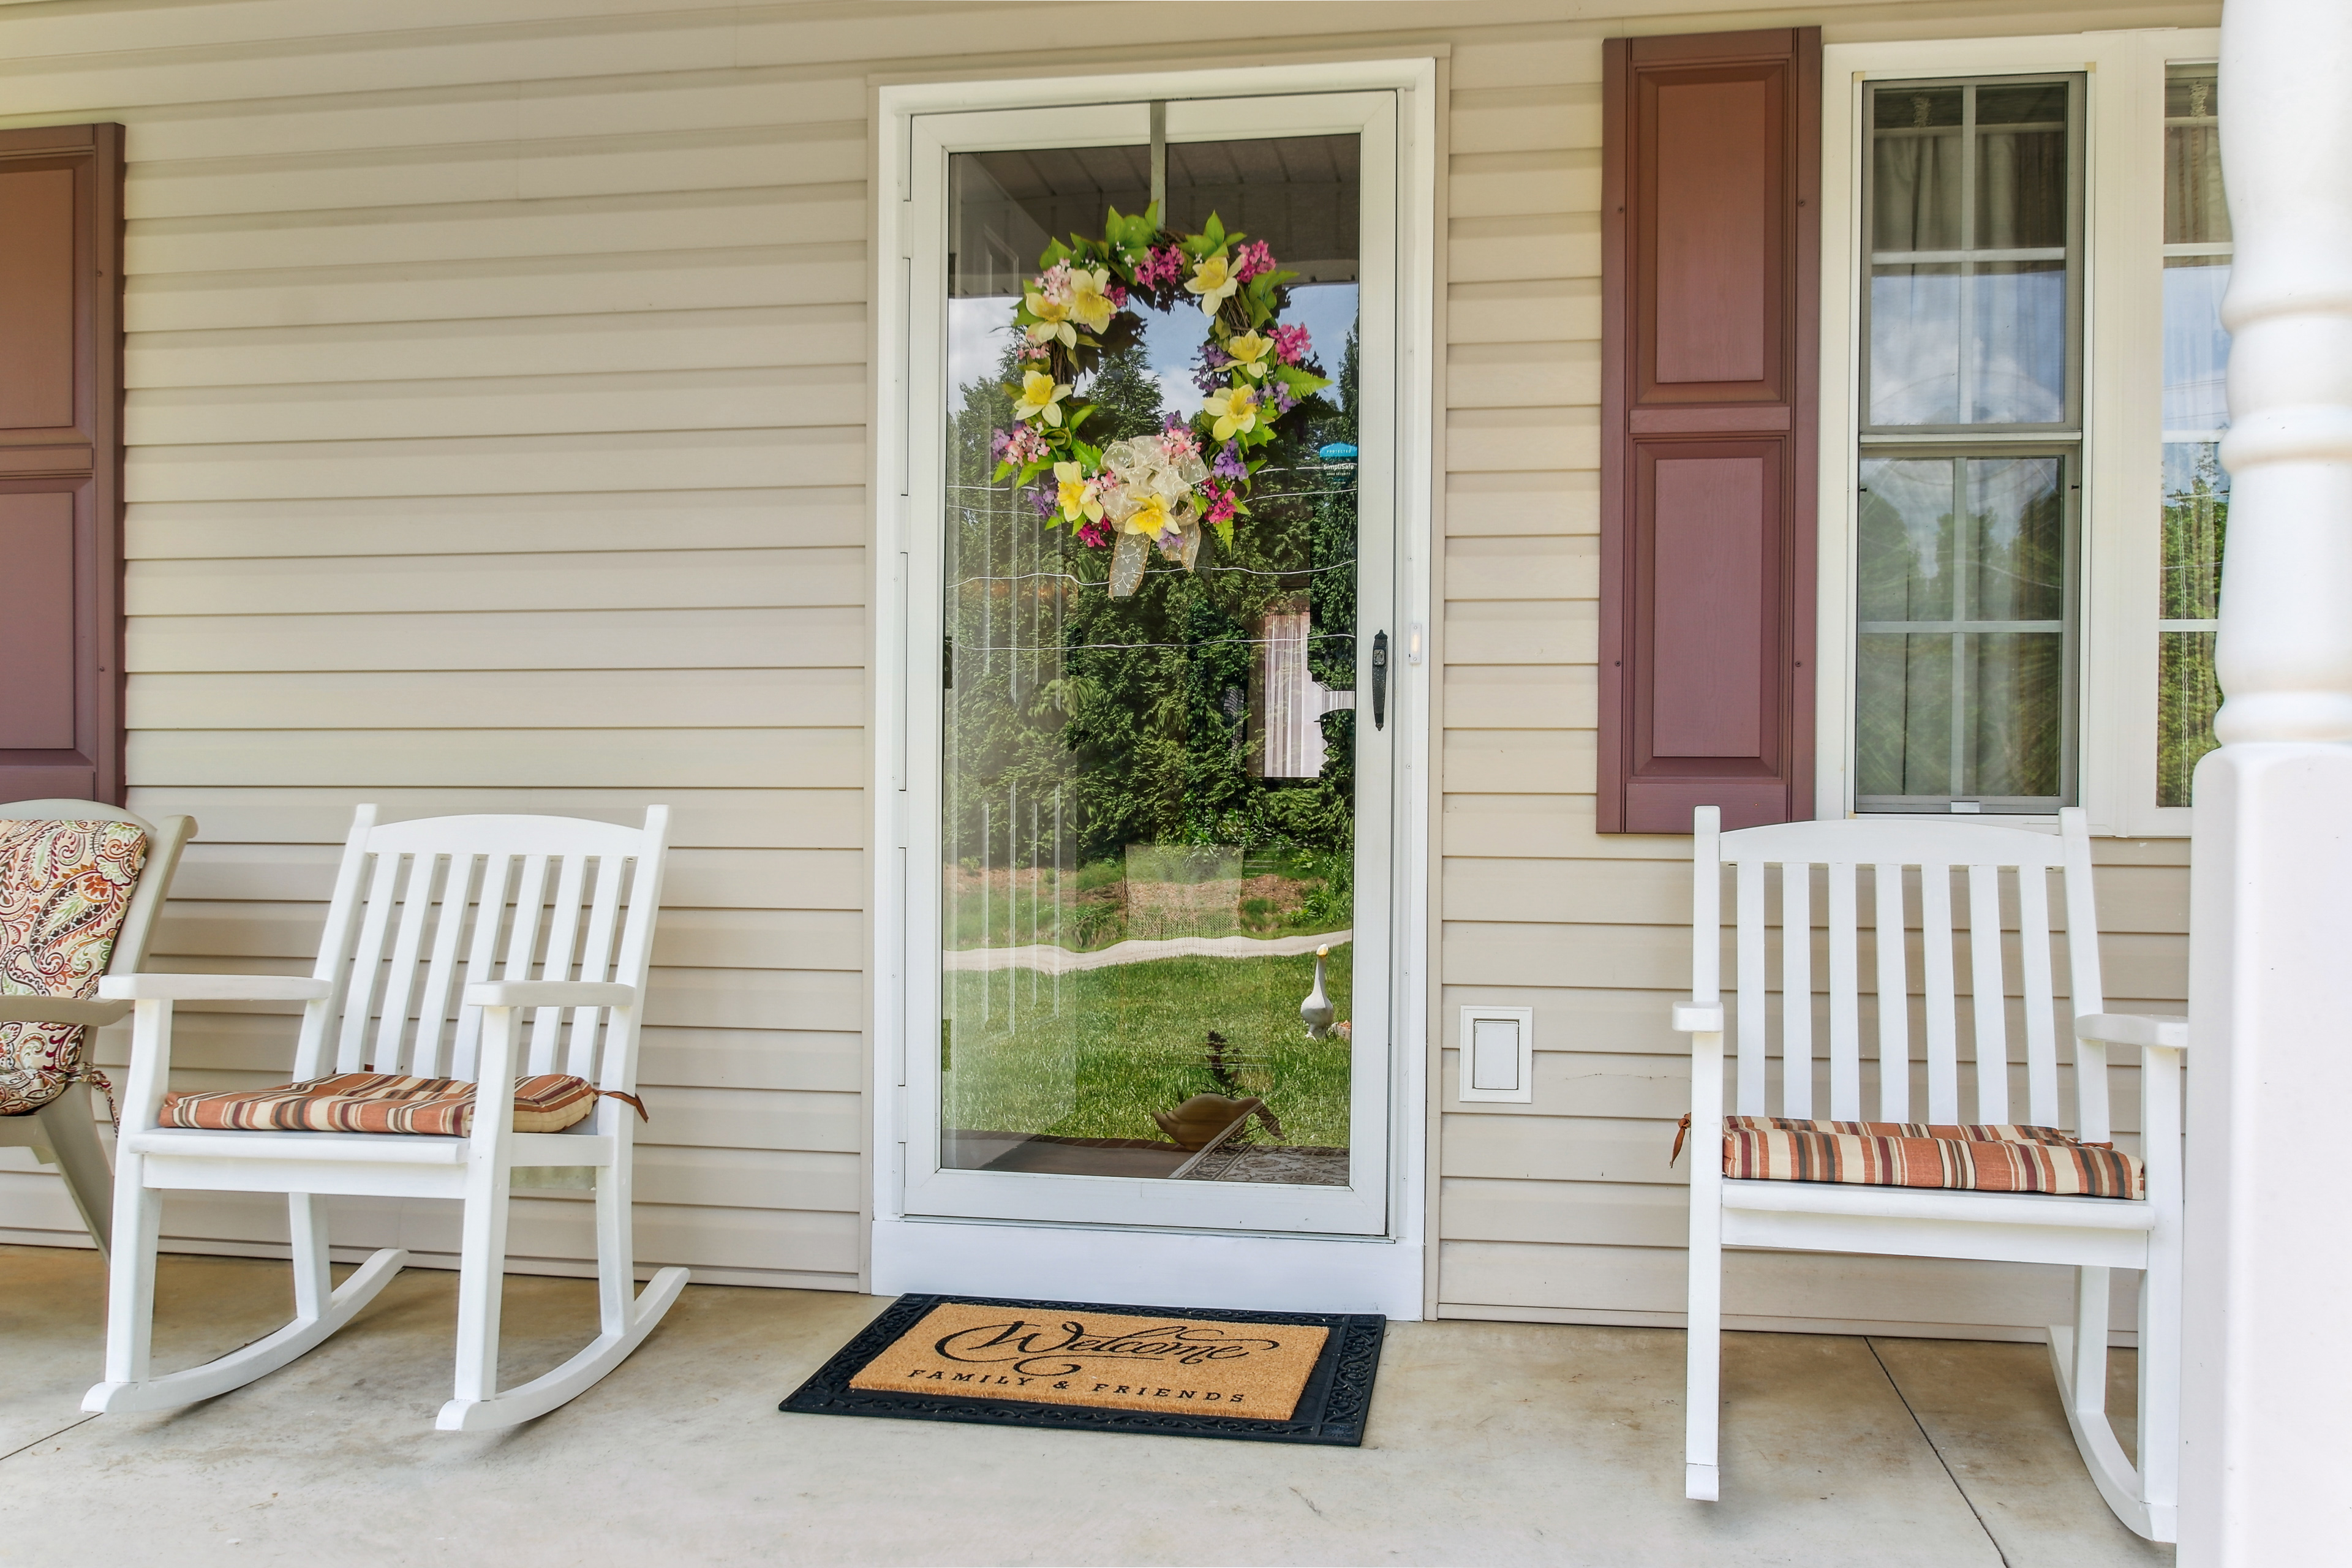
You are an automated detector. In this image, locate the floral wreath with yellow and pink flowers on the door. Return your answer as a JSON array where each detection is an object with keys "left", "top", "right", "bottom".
[{"left": 992, "top": 202, "right": 1331, "bottom": 597}]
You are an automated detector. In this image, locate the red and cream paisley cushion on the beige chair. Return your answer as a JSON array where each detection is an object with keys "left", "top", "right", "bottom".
[{"left": 0, "top": 820, "right": 146, "bottom": 1117}]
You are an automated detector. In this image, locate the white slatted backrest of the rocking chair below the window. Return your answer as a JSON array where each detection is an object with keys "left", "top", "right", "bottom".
[{"left": 1698, "top": 809, "right": 2109, "bottom": 1140}]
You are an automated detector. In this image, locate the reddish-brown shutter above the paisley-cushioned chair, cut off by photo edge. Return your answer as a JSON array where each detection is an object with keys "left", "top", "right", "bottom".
[{"left": 0, "top": 124, "right": 123, "bottom": 804}]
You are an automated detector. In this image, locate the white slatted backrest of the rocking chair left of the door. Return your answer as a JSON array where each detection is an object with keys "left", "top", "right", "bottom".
[{"left": 294, "top": 806, "right": 668, "bottom": 1091}]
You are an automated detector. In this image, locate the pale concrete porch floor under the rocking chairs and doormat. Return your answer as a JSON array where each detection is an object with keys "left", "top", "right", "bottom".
[{"left": 0, "top": 1248, "right": 2173, "bottom": 1568}]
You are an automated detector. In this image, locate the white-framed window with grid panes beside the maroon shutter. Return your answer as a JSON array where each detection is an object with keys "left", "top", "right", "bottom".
[{"left": 1815, "top": 28, "right": 2230, "bottom": 835}]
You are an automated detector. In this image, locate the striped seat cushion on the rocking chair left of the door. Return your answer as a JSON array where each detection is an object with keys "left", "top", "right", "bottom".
[{"left": 160, "top": 1072, "right": 597, "bottom": 1138}]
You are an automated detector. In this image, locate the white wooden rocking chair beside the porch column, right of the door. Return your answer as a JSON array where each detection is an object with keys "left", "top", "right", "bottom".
[{"left": 1675, "top": 806, "right": 2187, "bottom": 1540}]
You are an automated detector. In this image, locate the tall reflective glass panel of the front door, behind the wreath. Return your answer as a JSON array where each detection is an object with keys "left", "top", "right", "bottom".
[{"left": 910, "top": 95, "right": 1390, "bottom": 1229}]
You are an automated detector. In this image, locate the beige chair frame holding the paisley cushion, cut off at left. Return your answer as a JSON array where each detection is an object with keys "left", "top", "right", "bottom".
[{"left": 0, "top": 799, "right": 195, "bottom": 1253}]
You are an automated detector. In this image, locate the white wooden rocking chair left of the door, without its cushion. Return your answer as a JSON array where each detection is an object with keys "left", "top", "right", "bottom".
[{"left": 82, "top": 806, "right": 687, "bottom": 1431}]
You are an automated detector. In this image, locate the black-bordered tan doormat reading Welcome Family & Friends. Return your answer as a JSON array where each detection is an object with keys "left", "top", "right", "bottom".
[{"left": 778, "top": 1295, "right": 1388, "bottom": 1448}]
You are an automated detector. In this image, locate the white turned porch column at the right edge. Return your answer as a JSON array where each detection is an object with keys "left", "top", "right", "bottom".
[{"left": 2180, "top": 0, "right": 2352, "bottom": 1568}]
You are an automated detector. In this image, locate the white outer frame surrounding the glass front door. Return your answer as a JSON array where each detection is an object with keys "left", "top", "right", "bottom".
[{"left": 865, "top": 59, "right": 1437, "bottom": 1316}]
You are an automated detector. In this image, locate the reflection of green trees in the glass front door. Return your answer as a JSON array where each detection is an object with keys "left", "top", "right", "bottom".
[{"left": 946, "top": 315, "right": 1355, "bottom": 948}]
